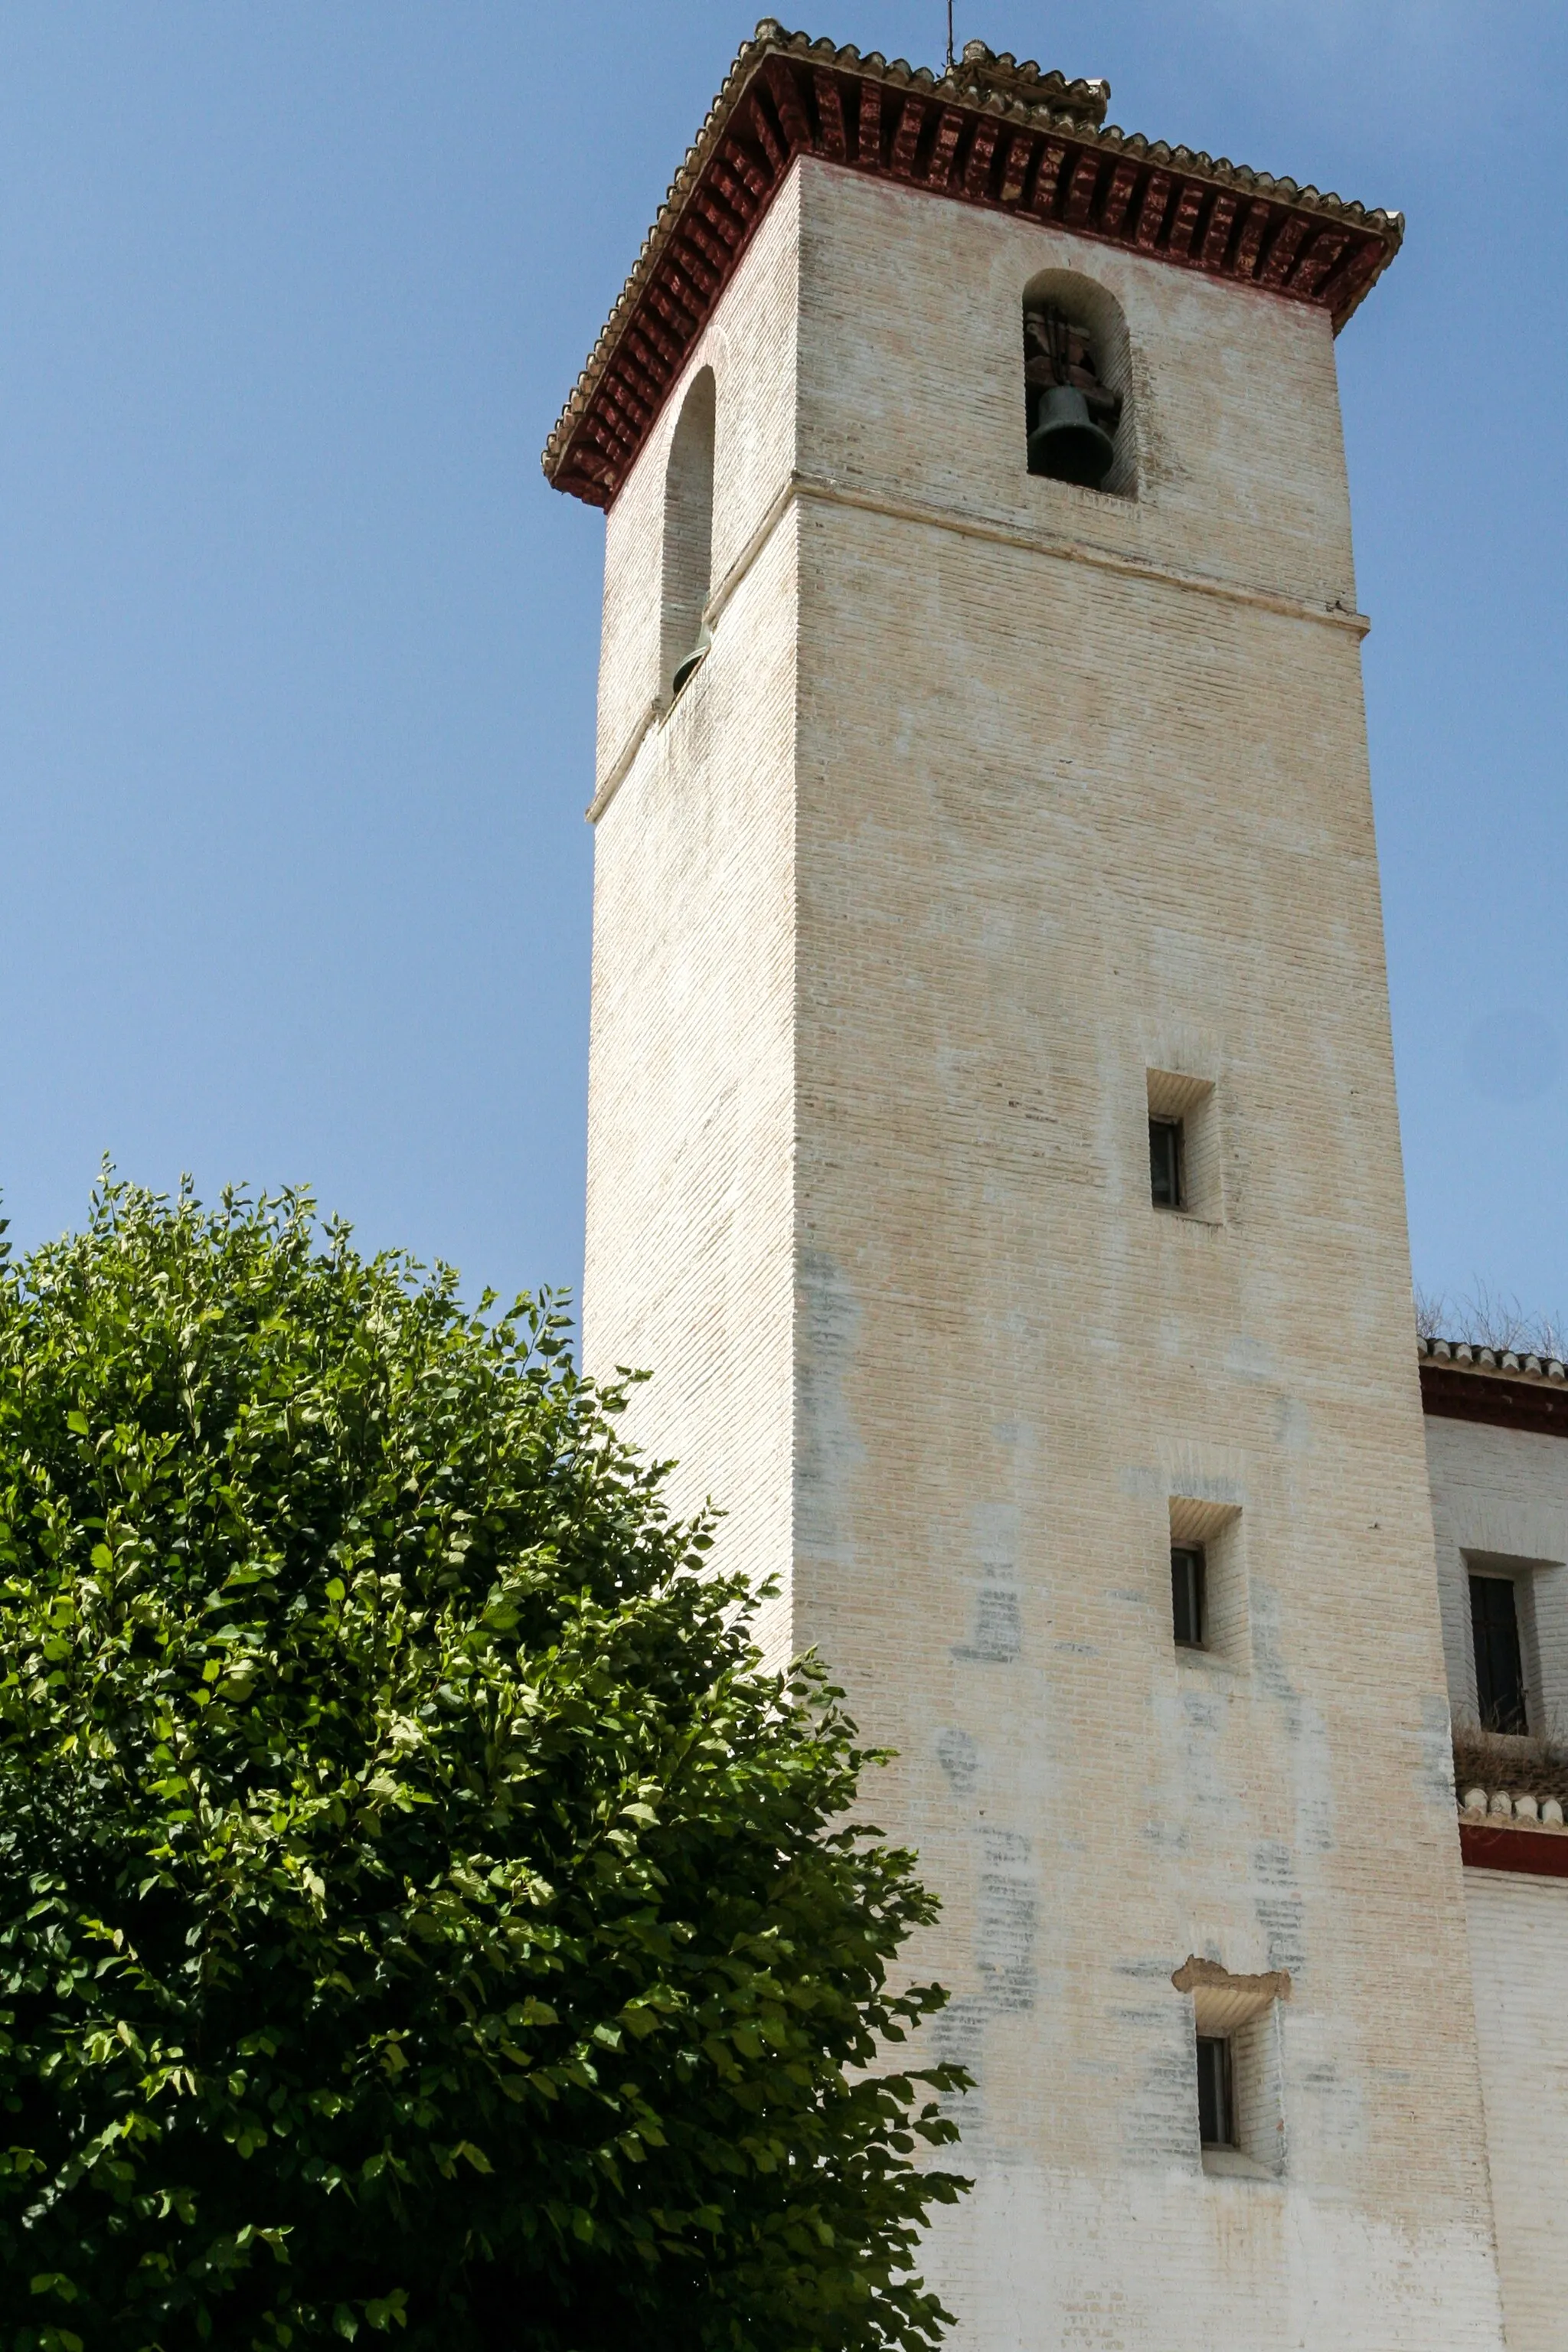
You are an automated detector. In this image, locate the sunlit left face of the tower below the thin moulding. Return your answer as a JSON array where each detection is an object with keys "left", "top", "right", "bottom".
[{"left": 583, "top": 514, "right": 795, "bottom": 1648}]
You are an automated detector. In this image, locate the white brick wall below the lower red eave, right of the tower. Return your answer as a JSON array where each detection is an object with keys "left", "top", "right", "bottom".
[{"left": 1465, "top": 1872, "right": 1568, "bottom": 2352}]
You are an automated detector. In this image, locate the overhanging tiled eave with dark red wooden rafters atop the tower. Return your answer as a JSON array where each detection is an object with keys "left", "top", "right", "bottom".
[{"left": 543, "top": 17, "right": 1403, "bottom": 508}]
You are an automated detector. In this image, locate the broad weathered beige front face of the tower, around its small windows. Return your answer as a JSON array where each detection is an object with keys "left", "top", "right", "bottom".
[{"left": 795, "top": 167, "right": 1500, "bottom": 2352}]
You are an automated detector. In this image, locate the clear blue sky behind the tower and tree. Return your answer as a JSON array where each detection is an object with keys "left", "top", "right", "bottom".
[{"left": 0, "top": 0, "right": 1568, "bottom": 1310}]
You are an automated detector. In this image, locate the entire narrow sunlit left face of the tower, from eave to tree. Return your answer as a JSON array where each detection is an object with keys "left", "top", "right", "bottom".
[{"left": 583, "top": 170, "right": 797, "bottom": 1648}]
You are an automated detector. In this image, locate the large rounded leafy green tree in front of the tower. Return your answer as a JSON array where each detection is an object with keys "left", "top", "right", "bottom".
[{"left": 0, "top": 1178, "right": 964, "bottom": 2352}]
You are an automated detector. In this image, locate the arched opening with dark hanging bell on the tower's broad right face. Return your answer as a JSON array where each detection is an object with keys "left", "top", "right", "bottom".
[{"left": 1023, "top": 270, "right": 1138, "bottom": 498}]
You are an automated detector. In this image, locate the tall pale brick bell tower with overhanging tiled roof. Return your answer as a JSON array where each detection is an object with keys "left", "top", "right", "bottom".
[{"left": 545, "top": 19, "right": 1502, "bottom": 2352}]
